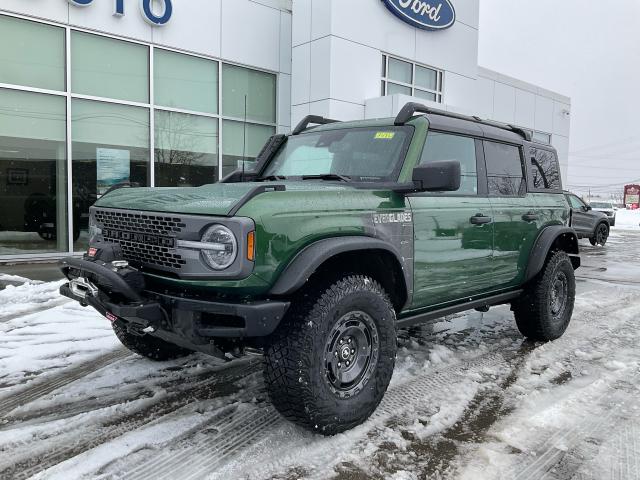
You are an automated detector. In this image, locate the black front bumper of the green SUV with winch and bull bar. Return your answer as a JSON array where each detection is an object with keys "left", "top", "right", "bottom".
[{"left": 60, "top": 258, "right": 289, "bottom": 348}]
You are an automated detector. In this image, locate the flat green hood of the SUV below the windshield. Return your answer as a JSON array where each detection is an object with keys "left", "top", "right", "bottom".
[{"left": 95, "top": 181, "right": 354, "bottom": 216}]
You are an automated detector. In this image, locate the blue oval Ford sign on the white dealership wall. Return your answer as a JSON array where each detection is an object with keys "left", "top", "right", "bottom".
[{"left": 382, "top": 0, "right": 456, "bottom": 30}]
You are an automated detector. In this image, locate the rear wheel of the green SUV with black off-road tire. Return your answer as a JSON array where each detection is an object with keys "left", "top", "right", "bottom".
[{"left": 512, "top": 251, "right": 576, "bottom": 342}]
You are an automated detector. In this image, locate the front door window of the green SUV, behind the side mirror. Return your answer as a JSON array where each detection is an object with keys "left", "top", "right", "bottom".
[{"left": 420, "top": 132, "right": 478, "bottom": 195}]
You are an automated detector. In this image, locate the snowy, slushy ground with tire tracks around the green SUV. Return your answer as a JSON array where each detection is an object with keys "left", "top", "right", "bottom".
[{"left": 0, "top": 231, "right": 640, "bottom": 480}]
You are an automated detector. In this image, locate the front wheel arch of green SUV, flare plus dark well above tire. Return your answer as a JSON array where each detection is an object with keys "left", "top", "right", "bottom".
[{"left": 269, "top": 236, "right": 413, "bottom": 311}]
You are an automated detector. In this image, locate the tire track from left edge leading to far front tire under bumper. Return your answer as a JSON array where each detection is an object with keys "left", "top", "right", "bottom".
[{"left": 0, "top": 348, "right": 133, "bottom": 422}]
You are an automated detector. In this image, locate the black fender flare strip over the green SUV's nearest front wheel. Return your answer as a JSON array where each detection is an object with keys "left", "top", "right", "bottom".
[{"left": 269, "top": 236, "right": 413, "bottom": 299}]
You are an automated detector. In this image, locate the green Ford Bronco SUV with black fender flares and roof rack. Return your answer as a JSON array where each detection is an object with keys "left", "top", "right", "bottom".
[{"left": 61, "top": 103, "right": 580, "bottom": 435}]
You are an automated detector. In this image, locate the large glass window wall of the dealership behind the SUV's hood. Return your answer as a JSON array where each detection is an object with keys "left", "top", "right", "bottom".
[{"left": 0, "top": 15, "right": 277, "bottom": 259}]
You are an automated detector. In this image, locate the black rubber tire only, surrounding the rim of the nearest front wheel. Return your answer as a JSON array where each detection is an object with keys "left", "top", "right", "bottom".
[{"left": 263, "top": 275, "right": 397, "bottom": 435}]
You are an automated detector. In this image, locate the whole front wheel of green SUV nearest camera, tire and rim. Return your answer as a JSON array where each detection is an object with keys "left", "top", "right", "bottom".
[{"left": 264, "top": 275, "right": 397, "bottom": 435}]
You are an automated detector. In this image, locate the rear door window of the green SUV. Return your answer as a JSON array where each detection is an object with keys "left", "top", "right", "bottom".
[{"left": 484, "top": 141, "right": 526, "bottom": 197}]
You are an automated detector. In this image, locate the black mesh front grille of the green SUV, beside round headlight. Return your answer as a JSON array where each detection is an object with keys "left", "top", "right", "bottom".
[{"left": 94, "top": 209, "right": 186, "bottom": 270}]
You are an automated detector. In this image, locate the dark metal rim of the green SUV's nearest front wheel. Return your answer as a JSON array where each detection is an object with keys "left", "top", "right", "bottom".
[{"left": 324, "top": 311, "right": 379, "bottom": 398}]
